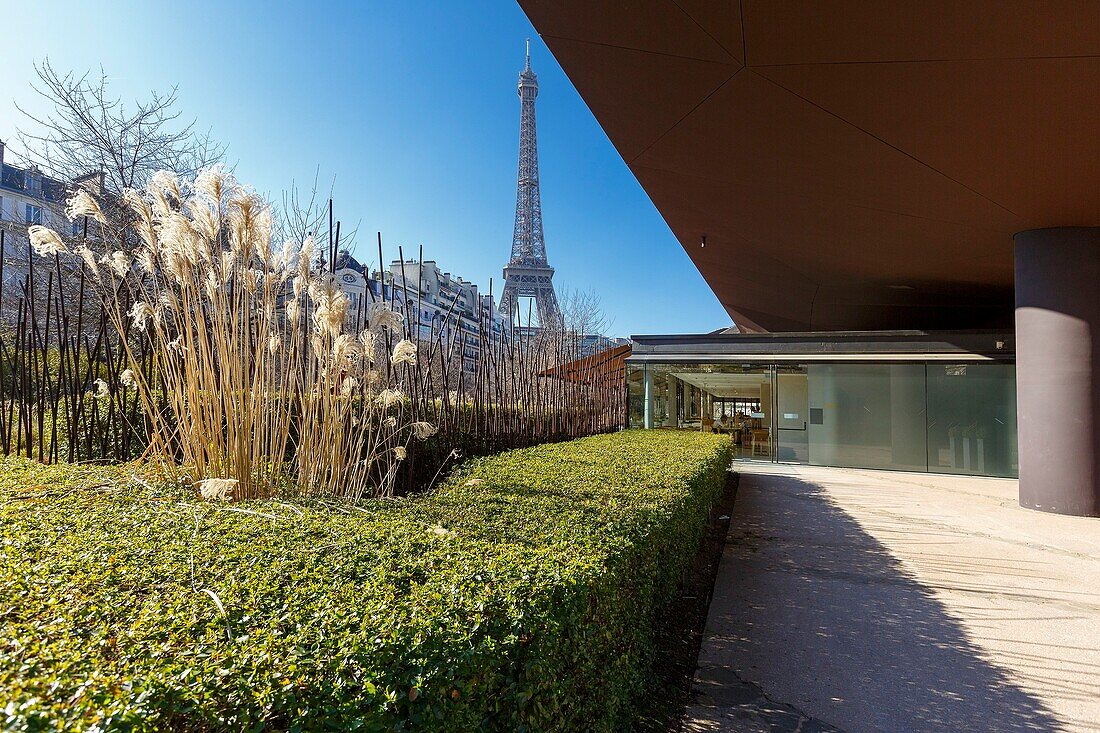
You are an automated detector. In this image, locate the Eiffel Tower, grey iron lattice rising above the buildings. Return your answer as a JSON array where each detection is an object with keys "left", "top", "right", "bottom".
[{"left": 501, "top": 40, "right": 562, "bottom": 328}]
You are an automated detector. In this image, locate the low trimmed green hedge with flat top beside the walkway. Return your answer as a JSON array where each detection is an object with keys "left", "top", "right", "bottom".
[{"left": 0, "top": 430, "right": 729, "bottom": 731}]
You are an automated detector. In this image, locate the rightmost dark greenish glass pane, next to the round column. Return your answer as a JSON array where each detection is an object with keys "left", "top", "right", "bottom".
[{"left": 927, "top": 363, "right": 1016, "bottom": 477}]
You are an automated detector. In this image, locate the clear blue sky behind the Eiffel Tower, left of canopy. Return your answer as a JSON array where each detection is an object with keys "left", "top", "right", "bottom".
[{"left": 0, "top": 0, "right": 729, "bottom": 336}]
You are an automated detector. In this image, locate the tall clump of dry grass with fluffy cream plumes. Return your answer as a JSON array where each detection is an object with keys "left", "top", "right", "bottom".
[{"left": 31, "top": 167, "right": 435, "bottom": 499}]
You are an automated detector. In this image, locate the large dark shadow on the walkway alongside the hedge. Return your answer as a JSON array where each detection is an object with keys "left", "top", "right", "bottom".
[{"left": 684, "top": 474, "right": 1064, "bottom": 733}]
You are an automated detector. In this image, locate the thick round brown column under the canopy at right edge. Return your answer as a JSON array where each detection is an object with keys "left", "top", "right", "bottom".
[{"left": 1014, "top": 227, "right": 1100, "bottom": 516}]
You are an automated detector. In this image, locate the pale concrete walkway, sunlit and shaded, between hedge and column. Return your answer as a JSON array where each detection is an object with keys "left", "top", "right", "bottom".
[{"left": 684, "top": 463, "right": 1100, "bottom": 733}]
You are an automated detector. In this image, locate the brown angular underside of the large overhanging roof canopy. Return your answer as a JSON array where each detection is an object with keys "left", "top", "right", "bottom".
[{"left": 519, "top": 0, "right": 1100, "bottom": 330}]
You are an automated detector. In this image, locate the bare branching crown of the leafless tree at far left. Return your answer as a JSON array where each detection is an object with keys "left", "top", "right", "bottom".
[{"left": 17, "top": 58, "right": 226, "bottom": 196}]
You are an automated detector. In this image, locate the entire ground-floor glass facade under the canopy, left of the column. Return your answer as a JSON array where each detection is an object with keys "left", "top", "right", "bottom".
[{"left": 627, "top": 361, "right": 1019, "bottom": 477}]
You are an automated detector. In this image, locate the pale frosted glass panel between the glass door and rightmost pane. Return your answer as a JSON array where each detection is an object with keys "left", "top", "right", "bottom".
[{"left": 806, "top": 363, "right": 926, "bottom": 471}]
